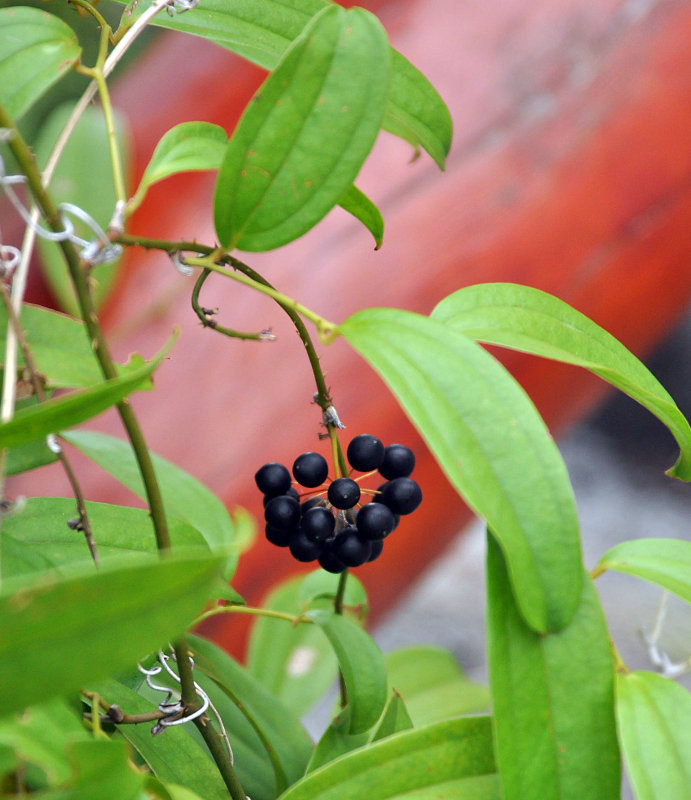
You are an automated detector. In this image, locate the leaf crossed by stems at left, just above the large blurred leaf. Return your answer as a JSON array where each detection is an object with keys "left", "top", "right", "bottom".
[{"left": 0, "top": 497, "right": 206, "bottom": 577}]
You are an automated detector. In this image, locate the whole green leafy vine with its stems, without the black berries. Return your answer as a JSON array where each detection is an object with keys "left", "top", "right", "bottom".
[{"left": 0, "top": 0, "right": 691, "bottom": 800}]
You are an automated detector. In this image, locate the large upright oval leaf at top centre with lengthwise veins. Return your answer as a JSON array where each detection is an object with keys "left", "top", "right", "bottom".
[{"left": 214, "top": 5, "right": 390, "bottom": 251}]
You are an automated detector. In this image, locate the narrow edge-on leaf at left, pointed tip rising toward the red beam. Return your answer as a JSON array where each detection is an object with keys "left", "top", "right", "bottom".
[{"left": 0, "top": 339, "right": 174, "bottom": 447}]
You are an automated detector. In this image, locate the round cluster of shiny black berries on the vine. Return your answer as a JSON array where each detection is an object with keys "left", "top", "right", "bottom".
[{"left": 254, "top": 433, "right": 422, "bottom": 572}]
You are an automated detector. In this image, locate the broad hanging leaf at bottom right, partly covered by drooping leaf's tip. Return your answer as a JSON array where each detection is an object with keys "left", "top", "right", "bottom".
[{"left": 487, "top": 536, "right": 620, "bottom": 800}]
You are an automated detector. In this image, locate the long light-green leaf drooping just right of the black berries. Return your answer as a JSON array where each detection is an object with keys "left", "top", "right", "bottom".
[{"left": 339, "top": 308, "right": 582, "bottom": 633}]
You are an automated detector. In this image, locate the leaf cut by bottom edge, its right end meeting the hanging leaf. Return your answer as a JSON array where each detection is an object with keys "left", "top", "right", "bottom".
[{"left": 280, "top": 717, "right": 501, "bottom": 800}]
